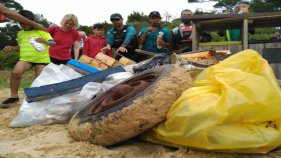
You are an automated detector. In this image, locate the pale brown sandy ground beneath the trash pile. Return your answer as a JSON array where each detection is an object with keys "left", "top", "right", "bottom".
[{"left": 0, "top": 89, "right": 281, "bottom": 158}]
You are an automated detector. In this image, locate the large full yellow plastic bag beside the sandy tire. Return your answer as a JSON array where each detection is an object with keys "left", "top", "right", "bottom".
[{"left": 143, "top": 50, "right": 281, "bottom": 153}]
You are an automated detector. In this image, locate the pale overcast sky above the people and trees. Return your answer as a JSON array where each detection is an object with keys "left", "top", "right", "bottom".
[{"left": 15, "top": 0, "right": 217, "bottom": 26}]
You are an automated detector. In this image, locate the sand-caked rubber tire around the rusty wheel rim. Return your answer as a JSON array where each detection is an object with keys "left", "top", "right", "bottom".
[{"left": 68, "top": 65, "right": 192, "bottom": 146}]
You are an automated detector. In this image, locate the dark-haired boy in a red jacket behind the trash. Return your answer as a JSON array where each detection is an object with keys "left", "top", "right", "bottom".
[{"left": 83, "top": 23, "right": 112, "bottom": 58}]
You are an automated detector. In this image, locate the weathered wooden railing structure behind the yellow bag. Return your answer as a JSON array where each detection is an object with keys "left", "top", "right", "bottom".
[{"left": 181, "top": 12, "right": 281, "bottom": 53}]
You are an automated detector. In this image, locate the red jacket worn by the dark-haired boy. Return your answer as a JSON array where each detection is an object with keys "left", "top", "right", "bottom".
[{"left": 83, "top": 35, "right": 112, "bottom": 58}]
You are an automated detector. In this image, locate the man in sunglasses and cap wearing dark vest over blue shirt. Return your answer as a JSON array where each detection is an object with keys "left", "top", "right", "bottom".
[{"left": 102, "top": 13, "right": 138, "bottom": 61}]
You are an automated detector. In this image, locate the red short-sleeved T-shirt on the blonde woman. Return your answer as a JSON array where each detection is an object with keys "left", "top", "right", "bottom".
[{"left": 48, "top": 26, "right": 81, "bottom": 60}]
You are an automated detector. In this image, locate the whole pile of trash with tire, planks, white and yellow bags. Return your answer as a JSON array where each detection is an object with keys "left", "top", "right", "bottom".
[{"left": 10, "top": 50, "right": 281, "bottom": 153}]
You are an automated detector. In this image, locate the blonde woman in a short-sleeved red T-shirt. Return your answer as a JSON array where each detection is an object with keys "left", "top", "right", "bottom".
[{"left": 48, "top": 14, "right": 81, "bottom": 65}]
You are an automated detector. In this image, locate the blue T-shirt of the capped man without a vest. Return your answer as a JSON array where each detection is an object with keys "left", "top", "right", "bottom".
[{"left": 139, "top": 27, "right": 171, "bottom": 54}]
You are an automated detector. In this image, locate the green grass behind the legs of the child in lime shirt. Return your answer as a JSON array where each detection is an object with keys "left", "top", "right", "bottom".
[{"left": 0, "top": 69, "right": 34, "bottom": 89}]
